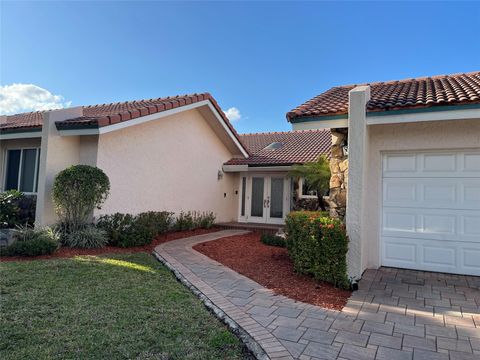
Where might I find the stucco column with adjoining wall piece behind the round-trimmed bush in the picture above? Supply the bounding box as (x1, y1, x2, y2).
(35, 107, 83, 226)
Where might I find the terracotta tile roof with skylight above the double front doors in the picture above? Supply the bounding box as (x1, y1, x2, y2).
(225, 130, 332, 166)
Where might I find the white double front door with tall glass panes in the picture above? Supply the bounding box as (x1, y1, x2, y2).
(240, 175, 290, 224)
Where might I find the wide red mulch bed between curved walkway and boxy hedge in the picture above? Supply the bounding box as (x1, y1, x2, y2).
(193, 233, 351, 310)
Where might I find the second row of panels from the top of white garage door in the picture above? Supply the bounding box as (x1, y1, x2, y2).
(383, 178, 480, 210)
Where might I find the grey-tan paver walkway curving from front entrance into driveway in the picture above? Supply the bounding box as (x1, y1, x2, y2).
(155, 230, 480, 360)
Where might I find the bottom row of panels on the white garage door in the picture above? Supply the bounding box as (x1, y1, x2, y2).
(382, 237, 480, 275)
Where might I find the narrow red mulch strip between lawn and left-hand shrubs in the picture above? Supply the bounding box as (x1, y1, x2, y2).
(0, 228, 220, 262)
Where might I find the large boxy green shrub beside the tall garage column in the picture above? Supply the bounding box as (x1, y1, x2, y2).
(286, 211, 350, 289)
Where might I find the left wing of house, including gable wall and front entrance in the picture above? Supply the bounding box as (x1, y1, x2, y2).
(0, 94, 331, 225)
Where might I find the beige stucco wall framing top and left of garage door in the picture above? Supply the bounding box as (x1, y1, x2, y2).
(362, 119, 480, 270)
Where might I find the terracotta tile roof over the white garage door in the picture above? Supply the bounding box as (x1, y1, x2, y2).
(287, 71, 480, 121)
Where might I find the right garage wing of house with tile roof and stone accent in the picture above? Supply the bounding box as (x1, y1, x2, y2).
(287, 72, 480, 279)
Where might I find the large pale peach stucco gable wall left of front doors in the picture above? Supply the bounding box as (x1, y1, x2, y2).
(95, 110, 238, 221)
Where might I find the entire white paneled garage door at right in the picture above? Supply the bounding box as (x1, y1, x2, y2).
(381, 150, 480, 275)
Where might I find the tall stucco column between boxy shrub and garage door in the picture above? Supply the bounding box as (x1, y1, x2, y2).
(345, 86, 370, 280)
